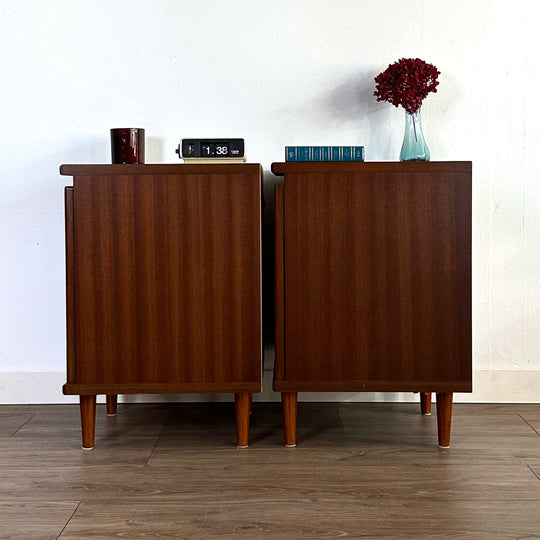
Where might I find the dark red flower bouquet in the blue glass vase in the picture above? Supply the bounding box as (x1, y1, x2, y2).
(373, 58, 441, 114)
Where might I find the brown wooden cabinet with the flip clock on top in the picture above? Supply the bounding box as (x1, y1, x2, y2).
(60, 164, 262, 448)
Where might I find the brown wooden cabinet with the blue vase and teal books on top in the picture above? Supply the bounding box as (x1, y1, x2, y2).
(272, 162, 472, 447)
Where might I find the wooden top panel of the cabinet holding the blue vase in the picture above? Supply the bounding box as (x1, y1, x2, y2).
(272, 161, 472, 176)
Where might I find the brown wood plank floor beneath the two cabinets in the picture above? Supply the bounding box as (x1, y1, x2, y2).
(0, 403, 540, 540)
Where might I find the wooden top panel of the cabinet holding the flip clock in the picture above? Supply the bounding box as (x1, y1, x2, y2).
(60, 163, 262, 176)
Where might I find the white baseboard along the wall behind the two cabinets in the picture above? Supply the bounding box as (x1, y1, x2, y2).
(0, 370, 540, 405)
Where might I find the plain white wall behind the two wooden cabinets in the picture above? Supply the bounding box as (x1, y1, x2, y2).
(0, 0, 540, 403)
